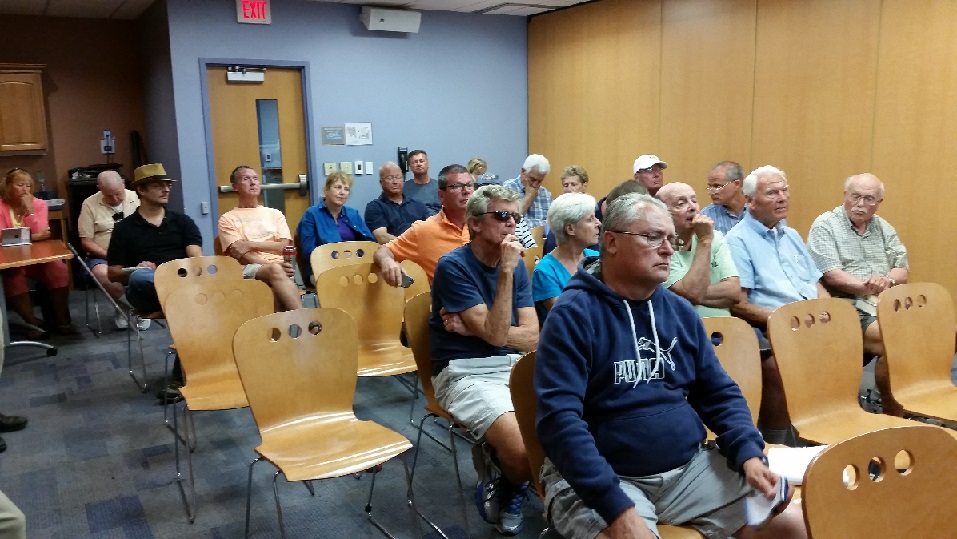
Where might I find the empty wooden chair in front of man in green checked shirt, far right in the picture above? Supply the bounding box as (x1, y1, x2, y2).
(877, 283, 957, 423)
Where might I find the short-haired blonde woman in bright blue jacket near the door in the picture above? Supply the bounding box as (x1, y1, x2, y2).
(296, 171, 375, 283)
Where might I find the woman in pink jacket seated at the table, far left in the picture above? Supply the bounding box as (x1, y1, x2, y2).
(0, 168, 76, 339)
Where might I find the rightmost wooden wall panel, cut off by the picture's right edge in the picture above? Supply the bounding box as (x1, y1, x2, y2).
(872, 0, 957, 294)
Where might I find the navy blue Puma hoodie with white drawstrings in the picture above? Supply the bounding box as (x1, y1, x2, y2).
(535, 257, 764, 523)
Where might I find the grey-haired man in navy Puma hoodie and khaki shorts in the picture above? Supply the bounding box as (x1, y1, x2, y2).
(534, 194, 806, 539)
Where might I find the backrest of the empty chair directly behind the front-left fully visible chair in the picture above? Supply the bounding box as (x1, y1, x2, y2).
(165, 278, 273, 392)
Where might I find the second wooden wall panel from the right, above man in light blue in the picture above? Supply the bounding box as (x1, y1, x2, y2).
(751, 0, 880, 237)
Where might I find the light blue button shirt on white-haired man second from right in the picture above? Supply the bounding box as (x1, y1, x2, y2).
(725, 213, 822, 309)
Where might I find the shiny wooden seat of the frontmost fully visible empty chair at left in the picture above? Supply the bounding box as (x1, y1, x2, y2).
(256, 417, 412, 481)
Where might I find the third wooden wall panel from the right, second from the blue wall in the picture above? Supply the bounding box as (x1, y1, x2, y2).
(656, 0, 757, 194)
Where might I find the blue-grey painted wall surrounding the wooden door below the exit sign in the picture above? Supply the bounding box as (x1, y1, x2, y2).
(160, 0, 528, 250)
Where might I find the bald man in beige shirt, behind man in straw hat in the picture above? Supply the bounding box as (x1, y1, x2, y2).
(76, 170, 142, 329)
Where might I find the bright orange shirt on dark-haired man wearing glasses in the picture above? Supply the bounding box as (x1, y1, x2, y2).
(385, 209, 472, 284)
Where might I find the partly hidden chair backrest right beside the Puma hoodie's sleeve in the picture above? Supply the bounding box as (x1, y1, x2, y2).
(704, 316, 762, 423)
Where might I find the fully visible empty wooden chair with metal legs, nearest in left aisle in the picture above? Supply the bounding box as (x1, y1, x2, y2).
(233, 308, 412, 537)
